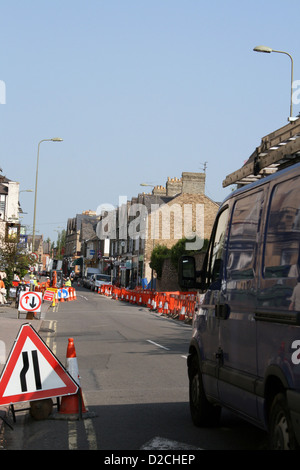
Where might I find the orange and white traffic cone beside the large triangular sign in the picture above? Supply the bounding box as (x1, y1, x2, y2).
(59, 338, 87, 416)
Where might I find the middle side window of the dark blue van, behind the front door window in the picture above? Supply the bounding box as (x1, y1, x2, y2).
(227, 191, 263, 279)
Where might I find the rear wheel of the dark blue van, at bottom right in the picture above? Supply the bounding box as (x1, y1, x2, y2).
(269, 393, 298, 450)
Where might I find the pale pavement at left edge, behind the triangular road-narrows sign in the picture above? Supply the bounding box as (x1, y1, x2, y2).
(0, 301, 51, 434)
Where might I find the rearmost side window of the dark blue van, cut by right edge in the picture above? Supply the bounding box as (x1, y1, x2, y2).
(263, 177, 300, 278)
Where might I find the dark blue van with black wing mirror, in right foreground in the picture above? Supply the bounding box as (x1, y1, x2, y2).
(179, 163, 300, 449)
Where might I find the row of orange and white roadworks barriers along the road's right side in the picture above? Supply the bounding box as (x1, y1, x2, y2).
(98, 284, 198, 323)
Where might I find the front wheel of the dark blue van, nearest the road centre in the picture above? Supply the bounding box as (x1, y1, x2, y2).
(189, 357, 221, 426)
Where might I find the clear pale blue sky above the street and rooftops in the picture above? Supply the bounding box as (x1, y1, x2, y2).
(0, 0, 300, 240)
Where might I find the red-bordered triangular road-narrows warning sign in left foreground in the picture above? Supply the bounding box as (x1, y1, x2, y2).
(0, 323, 79, 405)
